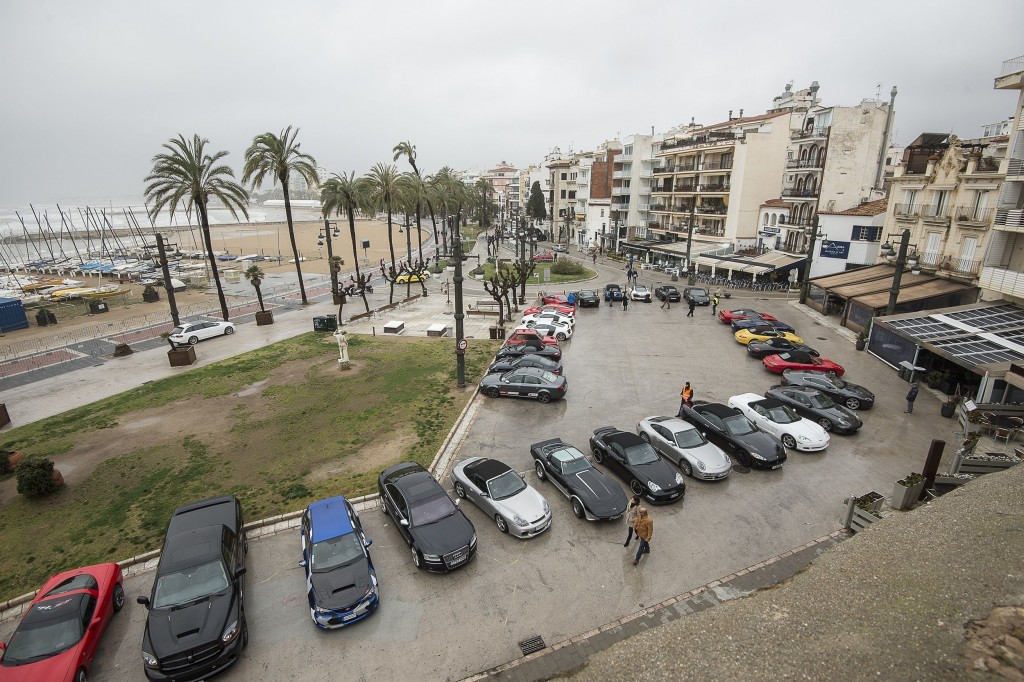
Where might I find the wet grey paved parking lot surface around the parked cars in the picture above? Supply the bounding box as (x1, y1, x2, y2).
(0, 280, 953, 680)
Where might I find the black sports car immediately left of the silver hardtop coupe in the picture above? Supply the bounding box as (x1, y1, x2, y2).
(590, 426, 686, 504)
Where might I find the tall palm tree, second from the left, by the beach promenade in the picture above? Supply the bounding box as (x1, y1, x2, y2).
(242, 126, 319, 305)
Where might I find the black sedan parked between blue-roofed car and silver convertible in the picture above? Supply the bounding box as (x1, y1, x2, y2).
(377, 462, 476, 573)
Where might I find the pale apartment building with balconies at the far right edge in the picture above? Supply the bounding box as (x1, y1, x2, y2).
(975, 55, 1024, 303)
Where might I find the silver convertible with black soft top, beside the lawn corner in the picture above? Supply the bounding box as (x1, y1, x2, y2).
(452, 457, 551, 538)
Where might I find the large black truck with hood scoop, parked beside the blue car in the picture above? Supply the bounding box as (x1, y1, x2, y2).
(138, 496, 249, 680)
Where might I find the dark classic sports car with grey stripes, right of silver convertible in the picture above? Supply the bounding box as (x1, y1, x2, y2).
(529, 438, 627, 521)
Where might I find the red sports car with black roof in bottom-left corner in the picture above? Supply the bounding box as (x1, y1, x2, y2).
(0, 563, 125, 682)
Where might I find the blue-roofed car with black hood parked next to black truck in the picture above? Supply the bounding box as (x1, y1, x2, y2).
(299, 496, 380, 630)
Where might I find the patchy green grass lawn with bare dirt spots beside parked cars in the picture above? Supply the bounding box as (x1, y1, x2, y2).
(0, 334, 498, 600)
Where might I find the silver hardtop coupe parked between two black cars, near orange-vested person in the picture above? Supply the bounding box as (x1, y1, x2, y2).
(637, 417, 732, 480)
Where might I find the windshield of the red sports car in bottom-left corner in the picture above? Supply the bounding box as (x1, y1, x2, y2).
(3, 594, 89, 667)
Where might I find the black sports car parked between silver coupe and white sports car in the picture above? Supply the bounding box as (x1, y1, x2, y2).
(683, 400, 786, 469)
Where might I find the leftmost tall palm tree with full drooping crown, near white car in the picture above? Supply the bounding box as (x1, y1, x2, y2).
(145, 135, 249, 322)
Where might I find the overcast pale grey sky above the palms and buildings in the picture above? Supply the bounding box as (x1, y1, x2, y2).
(0, 0, 1024, 205)
